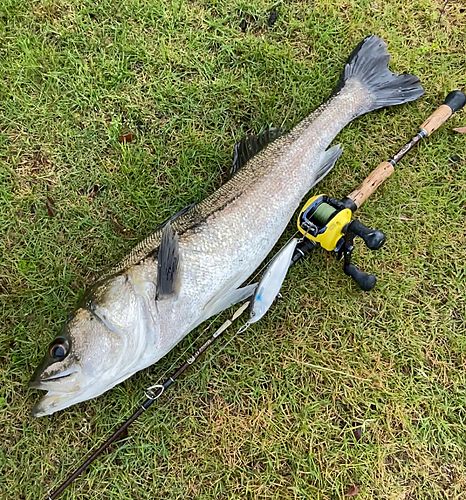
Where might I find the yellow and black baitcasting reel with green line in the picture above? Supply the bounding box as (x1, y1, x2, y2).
(293, 195, 385, 291)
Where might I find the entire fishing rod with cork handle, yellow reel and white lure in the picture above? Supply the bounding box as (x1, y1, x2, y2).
(42, 91, 466, 500)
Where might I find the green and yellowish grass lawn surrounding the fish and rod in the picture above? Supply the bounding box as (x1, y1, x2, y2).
(0, 0, 466, 500)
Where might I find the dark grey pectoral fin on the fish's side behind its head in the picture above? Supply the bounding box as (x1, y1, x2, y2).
(157, 221, 180, 300)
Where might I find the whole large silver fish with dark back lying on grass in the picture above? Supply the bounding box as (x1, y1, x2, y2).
(29, 35, 424, 417)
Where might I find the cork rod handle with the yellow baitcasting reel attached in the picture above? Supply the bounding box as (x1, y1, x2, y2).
(293, 90, 466, 291)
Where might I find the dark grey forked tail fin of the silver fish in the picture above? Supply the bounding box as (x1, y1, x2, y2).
(334, 35, 424, 114)
